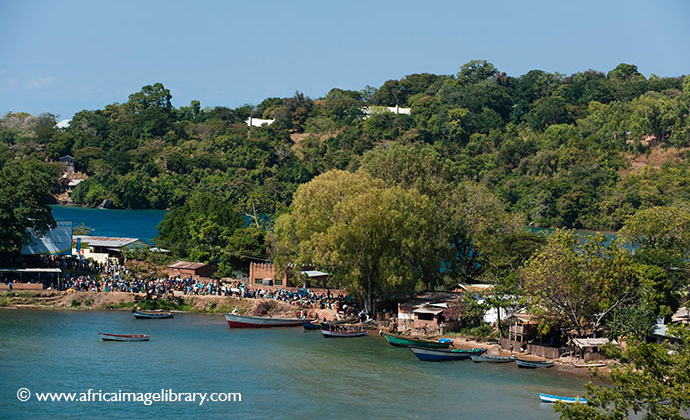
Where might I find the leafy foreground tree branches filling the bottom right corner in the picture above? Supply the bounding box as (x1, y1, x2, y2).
(555, 326, 690, 420)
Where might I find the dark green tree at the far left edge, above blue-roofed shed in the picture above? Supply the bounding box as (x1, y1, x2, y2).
(0, 159, 57, 256)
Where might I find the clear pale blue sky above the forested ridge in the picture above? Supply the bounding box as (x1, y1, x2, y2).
(0, 0, 690, 120)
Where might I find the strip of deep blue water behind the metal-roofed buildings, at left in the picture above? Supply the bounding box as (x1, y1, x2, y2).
(50, 206, 166, 242)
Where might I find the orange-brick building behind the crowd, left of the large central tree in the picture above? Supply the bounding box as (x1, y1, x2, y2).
(249, 262, 328, 289)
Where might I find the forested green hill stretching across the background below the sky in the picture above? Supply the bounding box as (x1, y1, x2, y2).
(0, 61, 690, 230)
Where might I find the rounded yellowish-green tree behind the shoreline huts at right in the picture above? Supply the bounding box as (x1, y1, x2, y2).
(520, 229, 641, 337)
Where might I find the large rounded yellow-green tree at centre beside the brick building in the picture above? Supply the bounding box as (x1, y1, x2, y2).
(274, 171, 441, 311)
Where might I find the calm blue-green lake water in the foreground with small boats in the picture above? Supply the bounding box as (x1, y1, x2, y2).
(0, 309, 584, 420)
